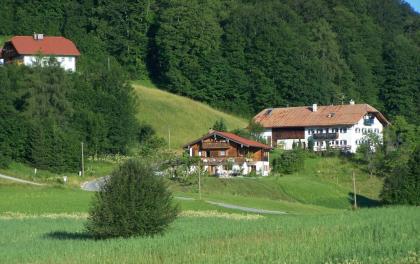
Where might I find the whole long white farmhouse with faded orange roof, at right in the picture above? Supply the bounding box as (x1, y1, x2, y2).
(254, 101, 389, 153)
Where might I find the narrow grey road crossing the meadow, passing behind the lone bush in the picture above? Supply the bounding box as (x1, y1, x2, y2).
(80, 177, 287, 215)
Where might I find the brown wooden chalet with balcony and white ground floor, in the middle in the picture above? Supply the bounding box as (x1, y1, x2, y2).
(184, 130, 271, 176)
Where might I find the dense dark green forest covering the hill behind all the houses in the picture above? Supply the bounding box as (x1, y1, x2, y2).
(0, 0, 420, 121)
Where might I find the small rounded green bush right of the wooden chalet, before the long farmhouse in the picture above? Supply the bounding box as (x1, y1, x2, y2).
(273, 149, 305, 174)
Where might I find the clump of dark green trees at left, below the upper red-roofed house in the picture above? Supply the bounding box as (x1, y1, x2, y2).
(0, 65, 141, 171)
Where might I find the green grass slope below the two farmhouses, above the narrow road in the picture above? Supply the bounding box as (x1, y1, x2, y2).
(173, 156, 382, 209)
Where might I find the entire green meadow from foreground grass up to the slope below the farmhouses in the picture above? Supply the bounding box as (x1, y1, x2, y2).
(0, 157, 420, 263)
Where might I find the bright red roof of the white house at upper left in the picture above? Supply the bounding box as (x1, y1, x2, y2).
(10, 36, 80, 56)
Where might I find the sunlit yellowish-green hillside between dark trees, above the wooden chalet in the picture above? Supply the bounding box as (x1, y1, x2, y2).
(133, 82, 247, 148)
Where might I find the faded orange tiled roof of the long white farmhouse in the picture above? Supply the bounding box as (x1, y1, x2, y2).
(254, 104, 389, 128)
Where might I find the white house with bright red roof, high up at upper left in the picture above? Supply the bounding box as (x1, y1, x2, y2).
(1, 33, 80, 72)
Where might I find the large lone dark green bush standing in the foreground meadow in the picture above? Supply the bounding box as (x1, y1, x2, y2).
(86, 160, 178, 238)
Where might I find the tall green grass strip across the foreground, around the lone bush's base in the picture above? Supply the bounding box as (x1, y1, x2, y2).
(0, 207, 420, 263)
